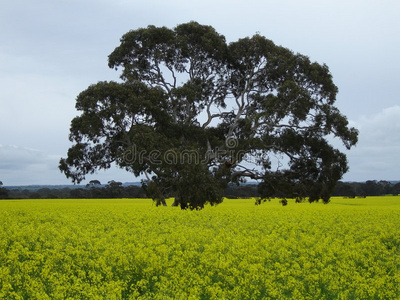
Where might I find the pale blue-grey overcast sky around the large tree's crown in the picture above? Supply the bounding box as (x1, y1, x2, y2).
(0, 0, 400, 185)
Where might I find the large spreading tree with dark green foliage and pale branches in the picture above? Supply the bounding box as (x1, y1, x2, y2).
(59, 22, 358, 208)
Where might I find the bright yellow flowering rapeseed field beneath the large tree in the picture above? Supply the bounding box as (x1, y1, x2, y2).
(0, 197, 400, 300)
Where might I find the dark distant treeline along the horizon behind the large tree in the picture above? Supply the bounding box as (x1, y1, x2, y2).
(0, 180, 400, 199)
